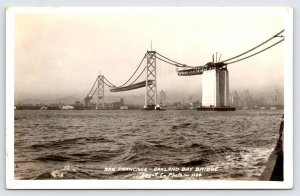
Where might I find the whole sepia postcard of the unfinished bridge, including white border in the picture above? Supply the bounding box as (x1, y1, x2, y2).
(6, 7, 293, 189)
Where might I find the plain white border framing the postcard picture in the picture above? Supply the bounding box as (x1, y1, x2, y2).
(6, 7, 293, 189)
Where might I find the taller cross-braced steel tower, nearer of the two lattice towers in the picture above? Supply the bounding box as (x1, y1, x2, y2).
(144, 51, 157, 109)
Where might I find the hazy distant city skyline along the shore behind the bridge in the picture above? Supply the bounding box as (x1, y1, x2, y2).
(15, 89, 284, 108)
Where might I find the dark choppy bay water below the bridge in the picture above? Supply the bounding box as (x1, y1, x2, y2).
(15, 110, 283, 180)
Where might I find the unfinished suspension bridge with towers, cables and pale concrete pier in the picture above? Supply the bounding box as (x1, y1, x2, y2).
(84, 30, 284, 110)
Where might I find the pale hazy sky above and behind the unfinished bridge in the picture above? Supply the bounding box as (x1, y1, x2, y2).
(15, 8, 285, 101)
